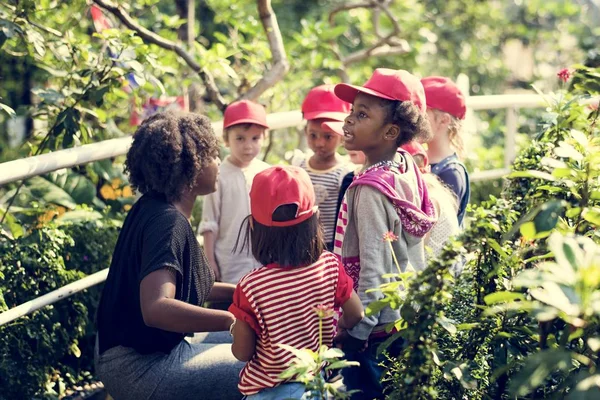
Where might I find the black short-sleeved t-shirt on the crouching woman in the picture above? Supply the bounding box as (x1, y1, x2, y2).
(98, 193, 214, 354)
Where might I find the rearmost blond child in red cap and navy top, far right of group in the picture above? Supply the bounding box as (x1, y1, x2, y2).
(421, 76, 471, 225)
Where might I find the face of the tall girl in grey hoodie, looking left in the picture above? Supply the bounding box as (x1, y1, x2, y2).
(344, 93, 395, 153)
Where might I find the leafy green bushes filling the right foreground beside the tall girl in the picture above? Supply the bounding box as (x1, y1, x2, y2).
(370, 70, 600, 399)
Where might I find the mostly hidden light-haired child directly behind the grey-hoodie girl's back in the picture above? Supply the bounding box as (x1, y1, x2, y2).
(401, 141, 461, 260)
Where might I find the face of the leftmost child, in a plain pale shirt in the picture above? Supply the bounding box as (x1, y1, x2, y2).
(225, 125, 265, 167)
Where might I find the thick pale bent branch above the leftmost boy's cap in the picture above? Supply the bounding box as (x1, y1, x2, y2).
(240, 0, 290, 100)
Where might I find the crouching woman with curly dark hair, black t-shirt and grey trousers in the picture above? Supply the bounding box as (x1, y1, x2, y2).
(95, 113, 243, 400)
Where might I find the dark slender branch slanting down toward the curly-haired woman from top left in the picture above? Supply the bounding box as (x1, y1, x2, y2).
(93, 0, 227, 111)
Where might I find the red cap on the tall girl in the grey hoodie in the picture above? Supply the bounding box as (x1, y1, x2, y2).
(335, 68, 426, 112)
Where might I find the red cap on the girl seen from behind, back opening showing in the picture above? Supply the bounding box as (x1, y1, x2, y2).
(250, 165, 318, 227)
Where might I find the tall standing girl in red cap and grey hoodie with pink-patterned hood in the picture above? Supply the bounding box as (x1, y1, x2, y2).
(335, 68, 436, 399)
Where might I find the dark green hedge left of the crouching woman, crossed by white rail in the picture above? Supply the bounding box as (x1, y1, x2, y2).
(0, 220, 118, 400)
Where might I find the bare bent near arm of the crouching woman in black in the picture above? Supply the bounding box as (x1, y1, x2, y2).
(140, 268, 234, 333)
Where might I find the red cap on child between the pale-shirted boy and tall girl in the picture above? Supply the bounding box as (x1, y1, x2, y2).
(302, 85, 352, 122)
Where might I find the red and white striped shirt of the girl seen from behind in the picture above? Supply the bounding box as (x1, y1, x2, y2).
(229, 251, 352, 396)
